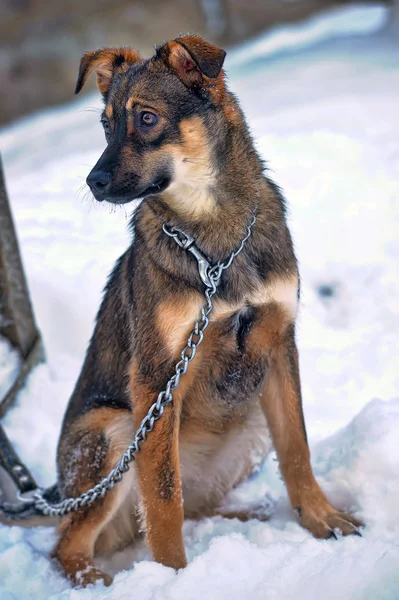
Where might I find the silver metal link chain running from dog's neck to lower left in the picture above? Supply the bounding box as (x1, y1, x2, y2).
(31, 213, 256, 517)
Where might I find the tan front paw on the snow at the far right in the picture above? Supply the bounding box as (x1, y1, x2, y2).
(295, 498, 364, 539)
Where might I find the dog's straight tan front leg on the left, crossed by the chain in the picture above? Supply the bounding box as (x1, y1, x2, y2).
(130, 368, 187, 569)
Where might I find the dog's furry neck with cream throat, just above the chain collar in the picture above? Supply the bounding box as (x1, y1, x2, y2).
(147, 110, 267, 259)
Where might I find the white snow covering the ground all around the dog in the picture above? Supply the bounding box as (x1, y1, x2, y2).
(0, 7, 399, 600)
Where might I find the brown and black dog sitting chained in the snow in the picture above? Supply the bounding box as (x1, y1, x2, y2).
(54, 36, 361, 585)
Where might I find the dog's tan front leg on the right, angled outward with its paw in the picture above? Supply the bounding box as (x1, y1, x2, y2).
(255, 315, 362, 538)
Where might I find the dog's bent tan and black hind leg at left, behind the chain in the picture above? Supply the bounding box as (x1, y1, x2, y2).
(52, 408, 135, 586)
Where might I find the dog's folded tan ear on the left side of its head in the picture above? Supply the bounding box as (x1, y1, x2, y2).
(75, 48, 141, 96)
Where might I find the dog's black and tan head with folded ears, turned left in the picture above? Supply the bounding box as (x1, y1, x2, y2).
(76, 36, 230, 213)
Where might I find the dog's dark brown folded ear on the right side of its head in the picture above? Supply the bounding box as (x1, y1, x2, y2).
(158, 35, 226, 86)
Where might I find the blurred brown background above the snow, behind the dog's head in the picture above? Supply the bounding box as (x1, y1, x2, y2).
(0, 0, 398, 126)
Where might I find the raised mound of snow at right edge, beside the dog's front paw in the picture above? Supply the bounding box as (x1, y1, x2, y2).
(313, 398, 399, 542)
